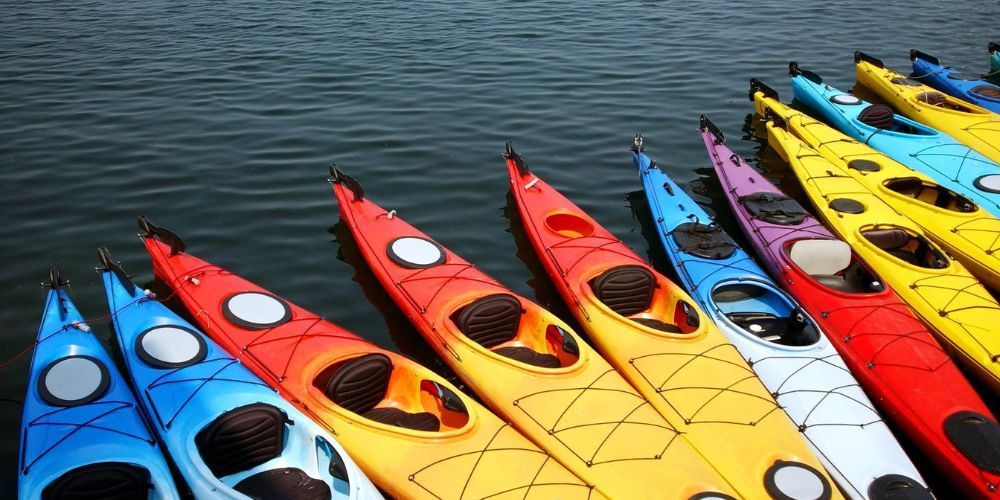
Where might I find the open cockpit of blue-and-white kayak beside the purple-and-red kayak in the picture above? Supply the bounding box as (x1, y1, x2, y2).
(712, 281, 820, 346)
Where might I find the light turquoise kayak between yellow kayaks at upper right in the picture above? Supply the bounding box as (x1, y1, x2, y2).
(789, 62, 1000, 216)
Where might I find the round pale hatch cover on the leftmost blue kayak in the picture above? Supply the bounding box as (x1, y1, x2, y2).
(38, 356, 111, 406)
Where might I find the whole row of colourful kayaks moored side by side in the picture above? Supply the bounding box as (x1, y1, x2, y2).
(19, 44, 1000, 500)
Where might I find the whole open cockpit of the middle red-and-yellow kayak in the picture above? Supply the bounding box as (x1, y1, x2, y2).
(451, 293, 580, 368)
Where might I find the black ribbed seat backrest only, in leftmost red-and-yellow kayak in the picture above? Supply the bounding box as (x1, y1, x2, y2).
(323, 352, 392, 414)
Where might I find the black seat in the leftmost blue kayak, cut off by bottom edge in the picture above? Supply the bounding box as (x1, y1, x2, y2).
(42, 462, 153, 500)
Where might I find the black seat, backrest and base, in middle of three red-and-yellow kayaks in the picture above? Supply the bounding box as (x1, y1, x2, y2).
(452, 293, 561, 368)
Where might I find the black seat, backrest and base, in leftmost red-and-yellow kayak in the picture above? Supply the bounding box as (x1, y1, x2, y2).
(323, 352, 441, 431)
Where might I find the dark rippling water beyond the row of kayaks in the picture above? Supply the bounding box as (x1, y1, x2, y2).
(0, 0, 1000, 497)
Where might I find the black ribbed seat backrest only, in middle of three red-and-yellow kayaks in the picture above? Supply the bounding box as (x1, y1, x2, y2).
(452, 293, 522, 349)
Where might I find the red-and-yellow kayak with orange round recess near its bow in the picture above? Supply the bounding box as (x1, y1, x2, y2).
(505, 143, 840, 498)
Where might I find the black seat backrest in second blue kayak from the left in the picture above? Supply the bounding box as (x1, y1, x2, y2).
(195, 403, 288, 477)
